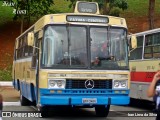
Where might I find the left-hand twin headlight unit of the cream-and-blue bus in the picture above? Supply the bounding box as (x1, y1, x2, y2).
(48, 79, 66, 89)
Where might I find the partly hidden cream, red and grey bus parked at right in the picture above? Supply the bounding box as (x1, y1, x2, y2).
(129, 28, 160, 101)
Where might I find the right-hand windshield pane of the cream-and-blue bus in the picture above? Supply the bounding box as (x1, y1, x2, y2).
(90, 27, 128, 69)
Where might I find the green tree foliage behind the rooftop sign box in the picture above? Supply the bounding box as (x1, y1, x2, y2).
(67, 0, 128, 16)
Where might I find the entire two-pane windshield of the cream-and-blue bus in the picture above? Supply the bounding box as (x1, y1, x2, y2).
(42, 25, 128, 69)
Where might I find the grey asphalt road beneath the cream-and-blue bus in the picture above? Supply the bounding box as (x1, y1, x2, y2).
(3, 106, 155, 120)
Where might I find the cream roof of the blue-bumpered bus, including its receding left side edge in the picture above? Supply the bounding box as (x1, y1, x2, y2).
(17, 13, 127, 39)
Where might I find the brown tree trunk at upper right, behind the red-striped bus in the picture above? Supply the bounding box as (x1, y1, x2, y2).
(148, 0, 155, 29)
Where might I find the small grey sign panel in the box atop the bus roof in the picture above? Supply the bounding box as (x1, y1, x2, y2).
(78, 2, 97, 14)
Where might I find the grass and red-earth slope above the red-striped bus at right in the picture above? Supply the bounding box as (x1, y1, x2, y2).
(121, 0, 160, 33)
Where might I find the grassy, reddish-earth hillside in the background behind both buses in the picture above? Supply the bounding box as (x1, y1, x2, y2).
(0, 0, 160, 80)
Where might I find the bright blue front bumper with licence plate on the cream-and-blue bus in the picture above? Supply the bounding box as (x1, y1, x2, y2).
(40, 95, 130, 106)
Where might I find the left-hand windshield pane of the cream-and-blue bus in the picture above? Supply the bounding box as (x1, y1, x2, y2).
(42, 25, 87, 68)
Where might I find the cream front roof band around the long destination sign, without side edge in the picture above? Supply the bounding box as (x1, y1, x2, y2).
(35, 13, 127, 31)
